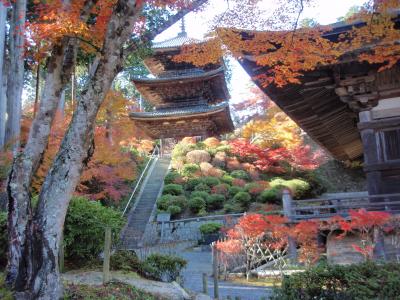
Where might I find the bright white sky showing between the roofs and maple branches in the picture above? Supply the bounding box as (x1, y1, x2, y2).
(155, 0, 365, 109)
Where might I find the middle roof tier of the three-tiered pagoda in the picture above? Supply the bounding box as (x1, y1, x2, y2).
(133, 66, 229, 106)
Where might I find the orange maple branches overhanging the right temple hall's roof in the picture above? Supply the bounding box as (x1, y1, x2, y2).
(175, 0, 400, 86)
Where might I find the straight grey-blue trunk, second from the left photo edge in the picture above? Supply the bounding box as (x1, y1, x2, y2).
(5, 0, 26, 153)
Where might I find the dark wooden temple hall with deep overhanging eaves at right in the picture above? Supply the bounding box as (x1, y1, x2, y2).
(234, 23, 400, 195)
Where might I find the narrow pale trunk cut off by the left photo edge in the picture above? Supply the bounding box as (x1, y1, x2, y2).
(0, 1, 7, 151)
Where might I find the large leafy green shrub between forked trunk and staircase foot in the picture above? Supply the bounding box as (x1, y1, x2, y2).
(64, 197, 125, 262)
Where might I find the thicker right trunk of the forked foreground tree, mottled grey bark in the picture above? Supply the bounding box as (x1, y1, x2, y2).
(9, 0, 141, 300)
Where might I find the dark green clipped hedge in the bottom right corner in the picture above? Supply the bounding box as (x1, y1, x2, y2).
(271, 262, 400, 300)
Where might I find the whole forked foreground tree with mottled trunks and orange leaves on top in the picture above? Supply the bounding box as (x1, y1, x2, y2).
(7, 0, 205, 299)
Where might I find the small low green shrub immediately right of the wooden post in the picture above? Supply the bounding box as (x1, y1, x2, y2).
(110, 250, 143, 274)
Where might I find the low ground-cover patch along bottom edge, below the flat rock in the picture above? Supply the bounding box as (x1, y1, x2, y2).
(64, 282, 156, 300)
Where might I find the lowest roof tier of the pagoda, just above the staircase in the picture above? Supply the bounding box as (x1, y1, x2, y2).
(129, 102, 234, 138)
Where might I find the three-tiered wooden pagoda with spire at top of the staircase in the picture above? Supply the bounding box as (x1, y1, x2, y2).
(130, 23, 234, 139)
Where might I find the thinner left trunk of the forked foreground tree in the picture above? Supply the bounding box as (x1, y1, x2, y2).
(6, 0, 97, 291)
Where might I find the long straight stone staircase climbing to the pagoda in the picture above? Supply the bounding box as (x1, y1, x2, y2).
(120, 157, 171, 249)
